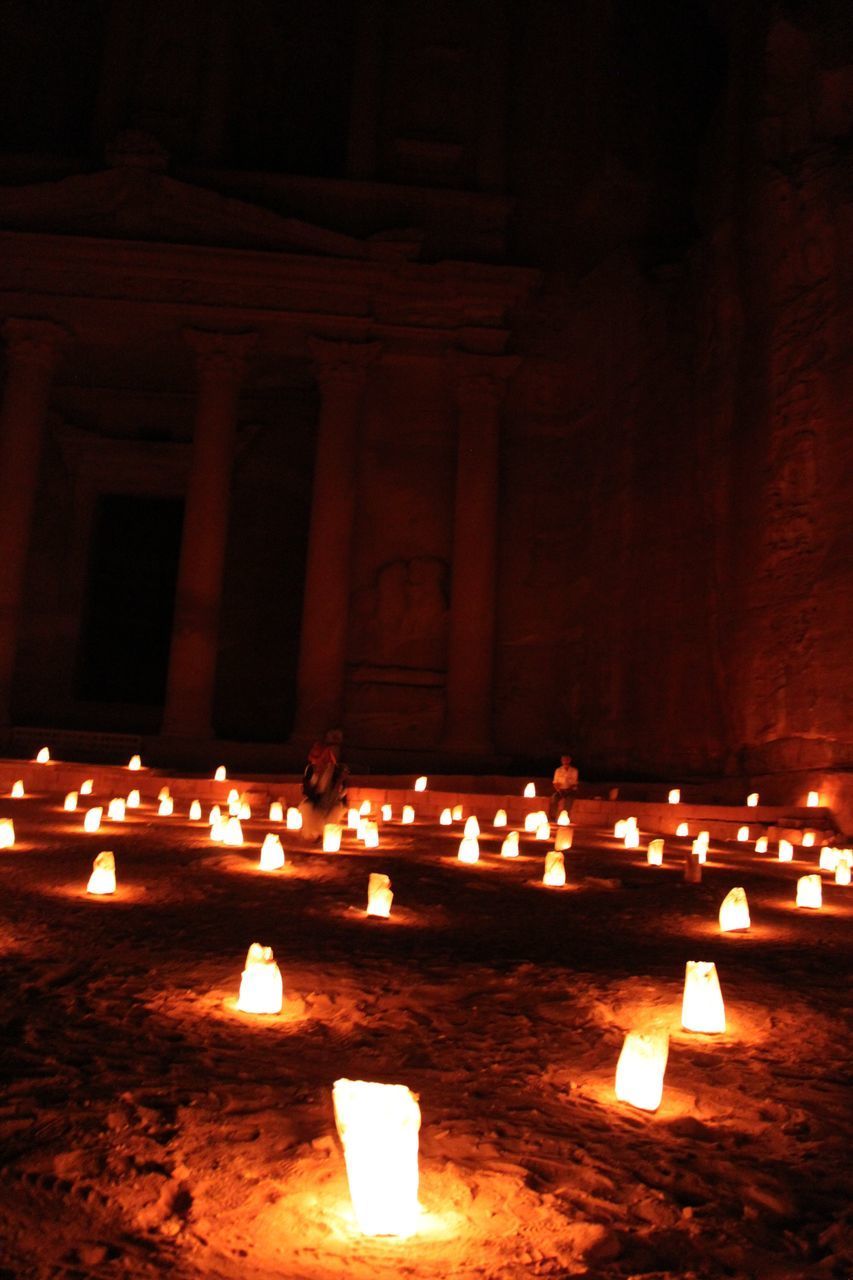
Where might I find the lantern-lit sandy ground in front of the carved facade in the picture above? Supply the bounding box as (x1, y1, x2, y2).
(0, 796, 853, 1280)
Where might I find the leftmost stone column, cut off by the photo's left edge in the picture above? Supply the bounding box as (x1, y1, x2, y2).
(0, 319, 67, 724)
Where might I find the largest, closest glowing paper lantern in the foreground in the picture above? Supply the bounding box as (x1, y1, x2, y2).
(332, 1079, 420, 1235)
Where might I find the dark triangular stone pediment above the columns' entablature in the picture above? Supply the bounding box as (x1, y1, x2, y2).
(0, 165, 418, 260)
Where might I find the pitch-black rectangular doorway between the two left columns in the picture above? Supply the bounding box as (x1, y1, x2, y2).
(77, 494, 183, 707)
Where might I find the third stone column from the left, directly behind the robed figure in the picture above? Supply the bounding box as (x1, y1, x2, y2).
(293, 338, 382, 742)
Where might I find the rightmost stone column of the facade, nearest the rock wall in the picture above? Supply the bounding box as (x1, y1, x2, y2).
(443, 353, 519, 753)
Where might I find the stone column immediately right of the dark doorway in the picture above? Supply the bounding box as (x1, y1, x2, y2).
(163, 329, 256, 739)
